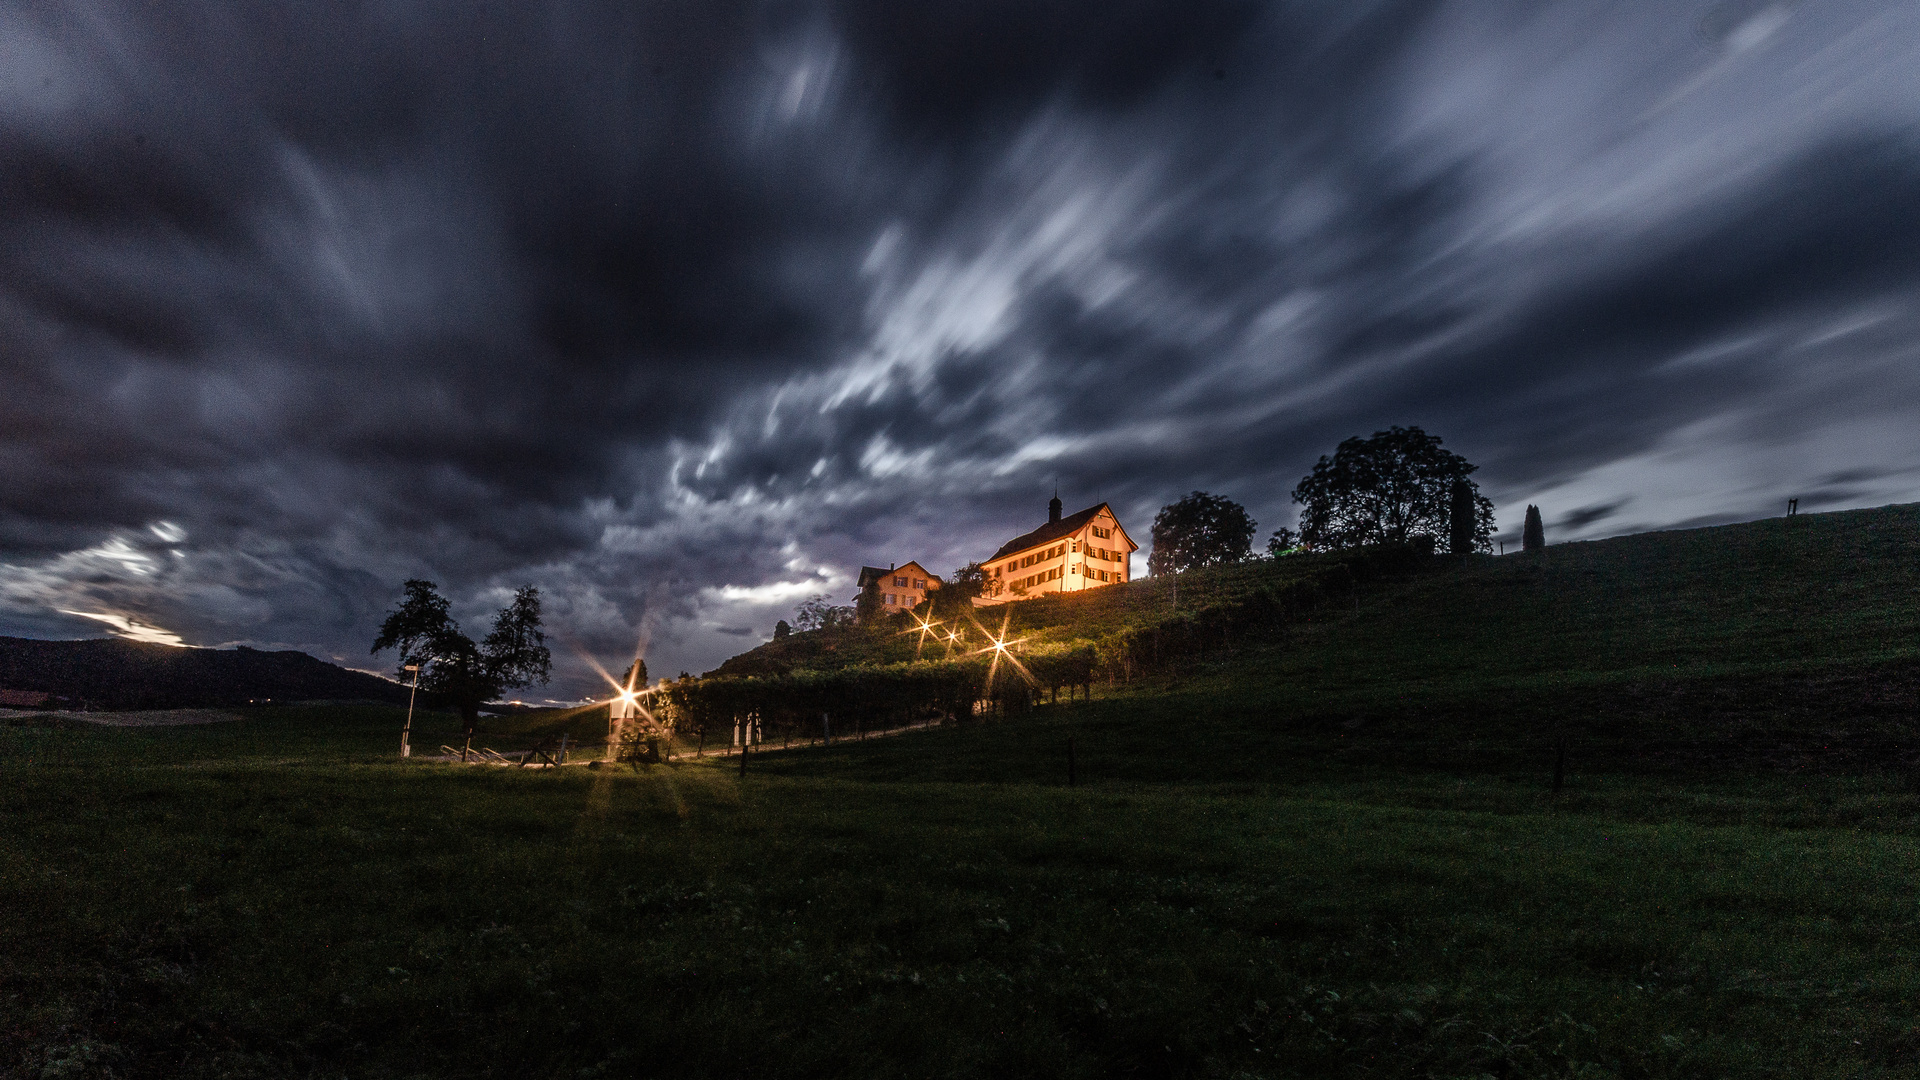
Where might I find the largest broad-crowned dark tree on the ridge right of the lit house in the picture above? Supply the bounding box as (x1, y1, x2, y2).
(1294, 427, 1494, 552)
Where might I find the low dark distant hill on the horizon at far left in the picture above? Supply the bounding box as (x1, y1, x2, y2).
(0, 638, 424, 709)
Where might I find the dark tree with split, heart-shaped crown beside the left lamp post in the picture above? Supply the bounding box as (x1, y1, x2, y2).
(372, 578, 553, 736)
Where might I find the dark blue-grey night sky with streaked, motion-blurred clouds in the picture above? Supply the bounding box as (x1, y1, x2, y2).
(0, 0, 1920, 698)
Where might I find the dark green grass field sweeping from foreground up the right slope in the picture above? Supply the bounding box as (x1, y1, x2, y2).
(11, 507, 1920, 1078)
